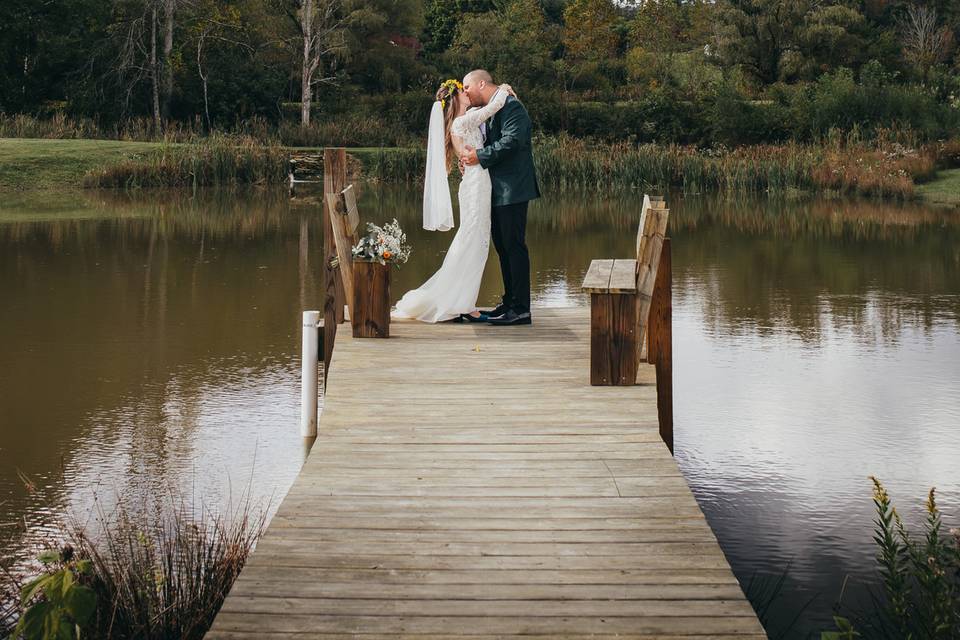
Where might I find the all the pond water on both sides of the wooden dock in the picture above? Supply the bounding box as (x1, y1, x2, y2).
(0, 185, 960, 638)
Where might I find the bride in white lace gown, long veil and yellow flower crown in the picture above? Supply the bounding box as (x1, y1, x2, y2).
(393, 80, 515, 322)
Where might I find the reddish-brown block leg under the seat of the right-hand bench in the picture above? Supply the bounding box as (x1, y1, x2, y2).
(590, 293, 640, 386)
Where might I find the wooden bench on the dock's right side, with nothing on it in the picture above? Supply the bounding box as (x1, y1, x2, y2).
(583, 196, 670, 385)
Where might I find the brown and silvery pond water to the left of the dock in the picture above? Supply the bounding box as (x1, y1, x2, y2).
(0, 193, 319, 568)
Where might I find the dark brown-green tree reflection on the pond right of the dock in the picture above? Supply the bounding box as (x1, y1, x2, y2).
(672, 203, 960, 341)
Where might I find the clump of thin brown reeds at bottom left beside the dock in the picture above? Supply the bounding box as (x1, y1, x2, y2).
(0, 498, 265, 640)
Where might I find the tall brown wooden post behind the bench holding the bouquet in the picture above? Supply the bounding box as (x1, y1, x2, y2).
(320, 148, 349, 386)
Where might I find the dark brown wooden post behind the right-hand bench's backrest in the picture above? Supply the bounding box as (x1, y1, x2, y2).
(647, 238, 673, 453)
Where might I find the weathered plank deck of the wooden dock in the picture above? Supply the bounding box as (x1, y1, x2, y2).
(207, 308, 766, 640)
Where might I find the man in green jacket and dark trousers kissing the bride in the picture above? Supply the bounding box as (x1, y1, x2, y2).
(461, 69, 540, 325)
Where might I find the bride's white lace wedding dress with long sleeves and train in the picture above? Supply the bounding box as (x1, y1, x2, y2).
(392, 91, 507, 322)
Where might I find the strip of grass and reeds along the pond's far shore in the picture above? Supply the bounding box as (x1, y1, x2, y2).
(0, 135, 960, 202)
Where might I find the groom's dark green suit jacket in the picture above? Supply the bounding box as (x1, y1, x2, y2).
(477, 96, 540, 207)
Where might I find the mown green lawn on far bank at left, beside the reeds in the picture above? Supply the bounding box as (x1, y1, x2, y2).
(0, 138, 160, 190)
